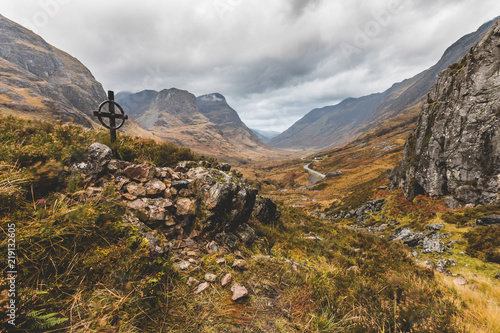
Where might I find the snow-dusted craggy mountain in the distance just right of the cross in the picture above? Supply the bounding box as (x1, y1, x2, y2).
(116, 88, 275, 163)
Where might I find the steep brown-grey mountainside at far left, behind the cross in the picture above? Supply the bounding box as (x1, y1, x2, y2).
(0, 15, 160, 141)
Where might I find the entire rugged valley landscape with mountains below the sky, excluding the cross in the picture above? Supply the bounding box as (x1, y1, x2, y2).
(0, 9, 500, 333)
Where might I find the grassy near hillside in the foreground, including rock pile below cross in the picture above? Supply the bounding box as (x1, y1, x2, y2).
(0, 118, 461, 332)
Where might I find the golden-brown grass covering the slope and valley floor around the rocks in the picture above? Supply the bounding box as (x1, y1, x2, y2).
(0, 119, 499, 332)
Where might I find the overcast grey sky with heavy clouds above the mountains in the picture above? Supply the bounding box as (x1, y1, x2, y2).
(1, 0, 500, 131)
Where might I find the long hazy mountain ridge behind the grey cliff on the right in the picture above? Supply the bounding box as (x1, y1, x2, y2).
(269, 16, 496, 150)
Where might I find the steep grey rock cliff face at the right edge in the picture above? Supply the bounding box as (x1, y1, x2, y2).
(392, 21, 500, 204)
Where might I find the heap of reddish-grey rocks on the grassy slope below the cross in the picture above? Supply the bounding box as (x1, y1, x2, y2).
(72, 143, 270, 252)
